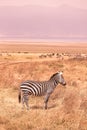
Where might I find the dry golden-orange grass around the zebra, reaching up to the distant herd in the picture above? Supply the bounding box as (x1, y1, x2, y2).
(0, 42, 87, 130)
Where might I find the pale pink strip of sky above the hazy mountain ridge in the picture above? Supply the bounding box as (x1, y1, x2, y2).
(0, 0, 87, 9)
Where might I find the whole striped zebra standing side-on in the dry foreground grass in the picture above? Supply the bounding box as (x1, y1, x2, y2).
(18, 72, 66, 109)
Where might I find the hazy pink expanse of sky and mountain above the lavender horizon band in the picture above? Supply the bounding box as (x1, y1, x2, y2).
(0, 0, 87, 39)
